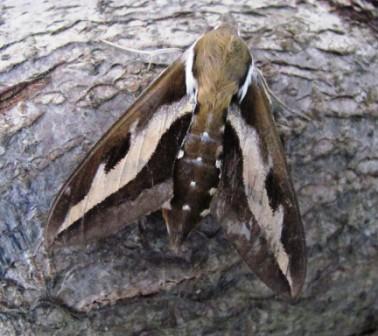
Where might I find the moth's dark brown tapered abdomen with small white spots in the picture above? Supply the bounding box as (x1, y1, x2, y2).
(163, 111, 223, 247)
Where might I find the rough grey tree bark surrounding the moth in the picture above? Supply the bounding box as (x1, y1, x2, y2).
(0, 0, 378, 336)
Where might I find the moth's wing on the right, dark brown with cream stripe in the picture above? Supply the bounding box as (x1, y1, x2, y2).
(212, 73, 306, 297)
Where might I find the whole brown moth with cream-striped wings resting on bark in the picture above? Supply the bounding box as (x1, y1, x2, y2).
(45, 23, 306, 297)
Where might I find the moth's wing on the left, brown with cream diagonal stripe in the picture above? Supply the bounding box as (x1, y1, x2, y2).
(46, 60, 192, 246)
